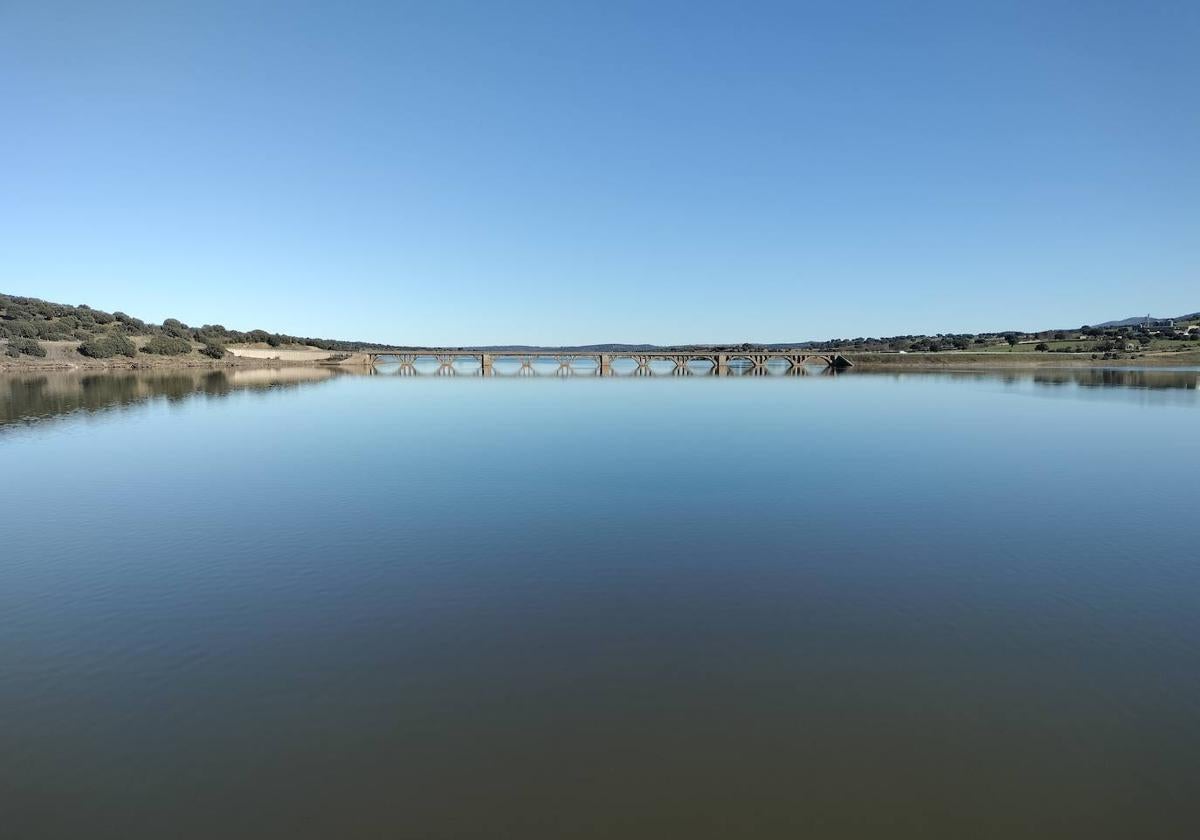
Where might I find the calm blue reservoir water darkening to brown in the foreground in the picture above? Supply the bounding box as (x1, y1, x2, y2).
(0, 371, 1200, 839)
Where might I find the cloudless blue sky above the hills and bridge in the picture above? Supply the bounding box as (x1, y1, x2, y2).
(0, 0, 1200, 344)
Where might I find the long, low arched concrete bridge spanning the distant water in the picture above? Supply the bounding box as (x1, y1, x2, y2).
(355, 348, 853, 377)
